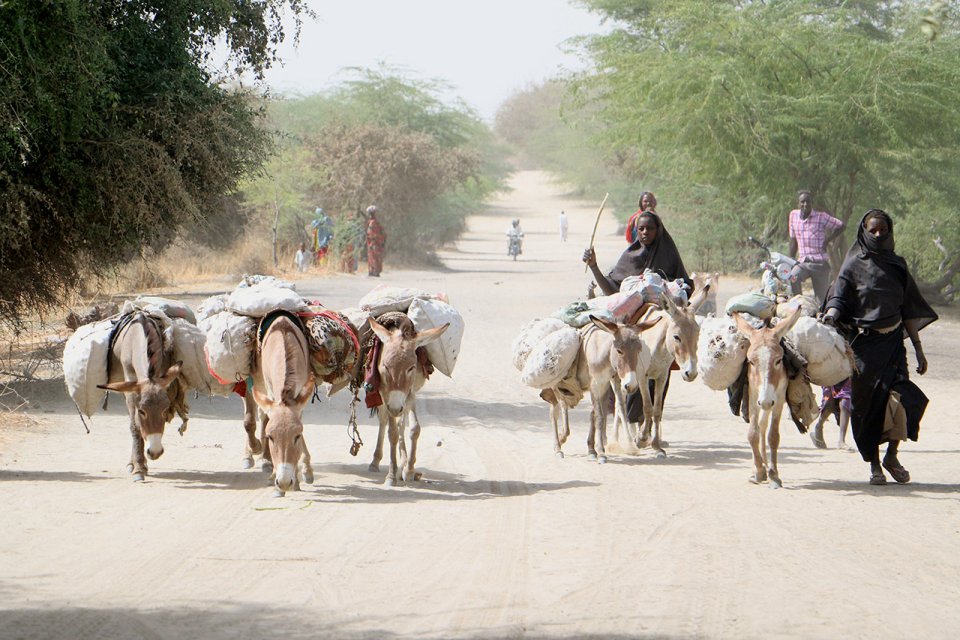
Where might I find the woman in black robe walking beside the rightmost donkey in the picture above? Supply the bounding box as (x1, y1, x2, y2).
(823, 209, 937, 484)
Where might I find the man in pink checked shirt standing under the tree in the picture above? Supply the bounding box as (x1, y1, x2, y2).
(789, 191, 846, 302)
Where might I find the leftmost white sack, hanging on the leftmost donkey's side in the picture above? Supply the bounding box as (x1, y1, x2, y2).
(63, 320, 113, 418)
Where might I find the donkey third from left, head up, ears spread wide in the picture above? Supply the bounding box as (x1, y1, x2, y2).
(369, 318, 450, 486)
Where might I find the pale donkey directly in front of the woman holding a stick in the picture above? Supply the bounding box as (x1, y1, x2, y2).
(622, 283, 710, 458)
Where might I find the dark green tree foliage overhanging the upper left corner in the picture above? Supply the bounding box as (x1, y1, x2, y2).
(0, 0, 304, 325)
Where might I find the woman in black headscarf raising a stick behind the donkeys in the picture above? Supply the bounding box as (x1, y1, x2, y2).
(583, 211, 693, 422)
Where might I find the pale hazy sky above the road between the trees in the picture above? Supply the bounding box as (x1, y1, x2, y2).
(267, 0, 602, 121)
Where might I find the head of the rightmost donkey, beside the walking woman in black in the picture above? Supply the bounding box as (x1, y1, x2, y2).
(733, 307, 801, 410)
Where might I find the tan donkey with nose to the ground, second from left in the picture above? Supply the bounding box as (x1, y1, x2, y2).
(251, 313, 315, 496)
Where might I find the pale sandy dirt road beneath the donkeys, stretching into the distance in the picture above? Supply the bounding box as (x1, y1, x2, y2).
(0, 173, 960, 639)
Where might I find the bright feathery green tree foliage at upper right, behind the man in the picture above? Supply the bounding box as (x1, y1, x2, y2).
(578, 0, 960, 288)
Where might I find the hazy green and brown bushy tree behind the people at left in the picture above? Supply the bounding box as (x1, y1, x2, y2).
(243, 68, 506, 268)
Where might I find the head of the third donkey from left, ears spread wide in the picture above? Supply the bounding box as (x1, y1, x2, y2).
(370, 318, 450, 417)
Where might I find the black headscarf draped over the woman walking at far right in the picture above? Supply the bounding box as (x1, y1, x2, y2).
(824, 209, 938, 331)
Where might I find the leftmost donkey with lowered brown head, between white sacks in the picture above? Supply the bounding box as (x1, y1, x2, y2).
(97, 311, 186, 482)
